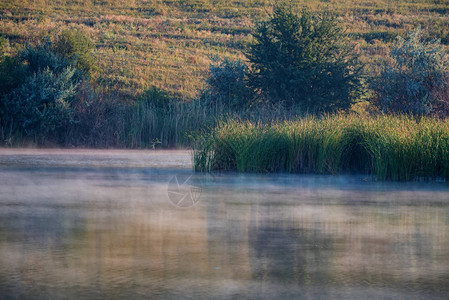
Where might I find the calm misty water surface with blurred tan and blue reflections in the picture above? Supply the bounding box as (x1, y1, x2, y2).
(0, 149, 449, 299)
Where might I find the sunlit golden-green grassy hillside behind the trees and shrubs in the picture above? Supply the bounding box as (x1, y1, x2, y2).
(0, 0, 449, 101)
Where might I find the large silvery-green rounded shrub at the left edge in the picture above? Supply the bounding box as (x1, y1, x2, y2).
(0, 38, 89, 142)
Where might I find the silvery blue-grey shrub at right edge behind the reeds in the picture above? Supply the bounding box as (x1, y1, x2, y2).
(373, 28, 449, 116)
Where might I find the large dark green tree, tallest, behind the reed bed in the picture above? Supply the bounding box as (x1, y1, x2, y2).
(247, 5, 362, 112)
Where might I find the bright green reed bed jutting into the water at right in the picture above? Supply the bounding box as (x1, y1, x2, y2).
(194, 115, 449, 181)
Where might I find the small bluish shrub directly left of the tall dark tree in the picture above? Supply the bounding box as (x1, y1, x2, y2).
(207, 57, 253, 109)
